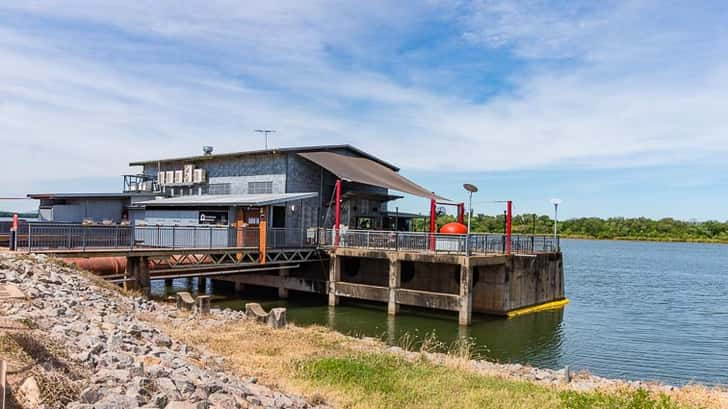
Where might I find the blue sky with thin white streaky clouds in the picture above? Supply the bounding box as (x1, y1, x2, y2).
(0, 0, 728, 220)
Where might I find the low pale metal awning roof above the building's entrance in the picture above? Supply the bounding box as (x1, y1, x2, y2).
(135, 192, 318, 207)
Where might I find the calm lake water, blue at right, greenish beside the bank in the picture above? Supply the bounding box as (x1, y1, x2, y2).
(154, 240, 728, 384)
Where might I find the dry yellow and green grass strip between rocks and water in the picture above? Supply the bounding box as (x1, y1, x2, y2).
(142, 317, 728, 409)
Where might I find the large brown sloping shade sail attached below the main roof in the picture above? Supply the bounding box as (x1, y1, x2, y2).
(299, 152, 448, 200)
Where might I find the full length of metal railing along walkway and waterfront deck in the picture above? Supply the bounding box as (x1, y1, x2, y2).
(11, 223, 559, 254)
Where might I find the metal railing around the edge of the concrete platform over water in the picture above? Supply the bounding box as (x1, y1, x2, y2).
(318, 229, 559, 254)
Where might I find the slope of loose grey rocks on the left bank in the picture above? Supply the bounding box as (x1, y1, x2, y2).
(0, 254, 328, 409)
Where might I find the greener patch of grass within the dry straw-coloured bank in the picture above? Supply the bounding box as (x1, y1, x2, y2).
(297, 353, 679, 409)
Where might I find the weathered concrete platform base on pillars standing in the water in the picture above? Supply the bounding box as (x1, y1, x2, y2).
(208, 242, 566, 326)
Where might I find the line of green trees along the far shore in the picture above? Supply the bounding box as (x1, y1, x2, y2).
(413, 214, 728, 242)
